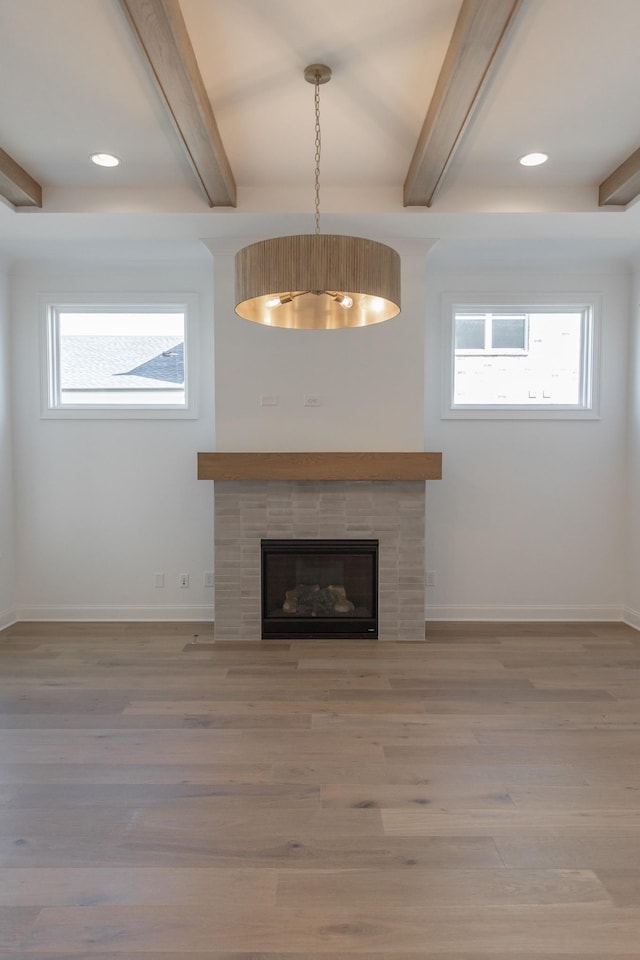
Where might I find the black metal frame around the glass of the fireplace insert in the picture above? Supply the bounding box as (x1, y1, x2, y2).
(260, 538, 379, 640)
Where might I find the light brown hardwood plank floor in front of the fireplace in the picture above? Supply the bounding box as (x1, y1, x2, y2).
(0, 624, 640, 960)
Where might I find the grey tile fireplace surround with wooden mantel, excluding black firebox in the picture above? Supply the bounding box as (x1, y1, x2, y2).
(198, 454, 440, 640)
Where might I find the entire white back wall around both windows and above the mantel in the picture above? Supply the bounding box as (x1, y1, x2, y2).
(0, 244, 640, 625)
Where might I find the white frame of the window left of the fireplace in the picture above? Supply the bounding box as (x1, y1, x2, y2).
(40, 292, 198, 420)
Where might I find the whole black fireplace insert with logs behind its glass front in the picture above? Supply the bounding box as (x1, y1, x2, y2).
(260, 539, 378, 639)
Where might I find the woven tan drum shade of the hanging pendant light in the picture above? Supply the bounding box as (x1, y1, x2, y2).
(235, 233, 400, 330)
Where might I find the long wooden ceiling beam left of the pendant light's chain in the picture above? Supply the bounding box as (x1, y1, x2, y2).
(120, 0, 236, 207)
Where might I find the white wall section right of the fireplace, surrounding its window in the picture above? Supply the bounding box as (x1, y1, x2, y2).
(425, 262, 629, 620)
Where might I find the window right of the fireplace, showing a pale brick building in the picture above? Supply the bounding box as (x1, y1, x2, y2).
(442, 296, 599, 419)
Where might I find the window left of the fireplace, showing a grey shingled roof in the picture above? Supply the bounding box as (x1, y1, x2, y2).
(42, 295, 196, 418)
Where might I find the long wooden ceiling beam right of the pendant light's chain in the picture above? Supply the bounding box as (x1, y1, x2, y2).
(404, 0, 522, 207)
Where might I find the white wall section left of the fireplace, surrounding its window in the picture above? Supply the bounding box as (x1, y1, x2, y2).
(12, 253, 214, 620)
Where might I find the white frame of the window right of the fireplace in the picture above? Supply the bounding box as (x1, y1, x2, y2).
(441, 292, 602, 420)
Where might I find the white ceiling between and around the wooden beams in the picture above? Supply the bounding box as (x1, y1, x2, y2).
(0, 0, 640, 257)
